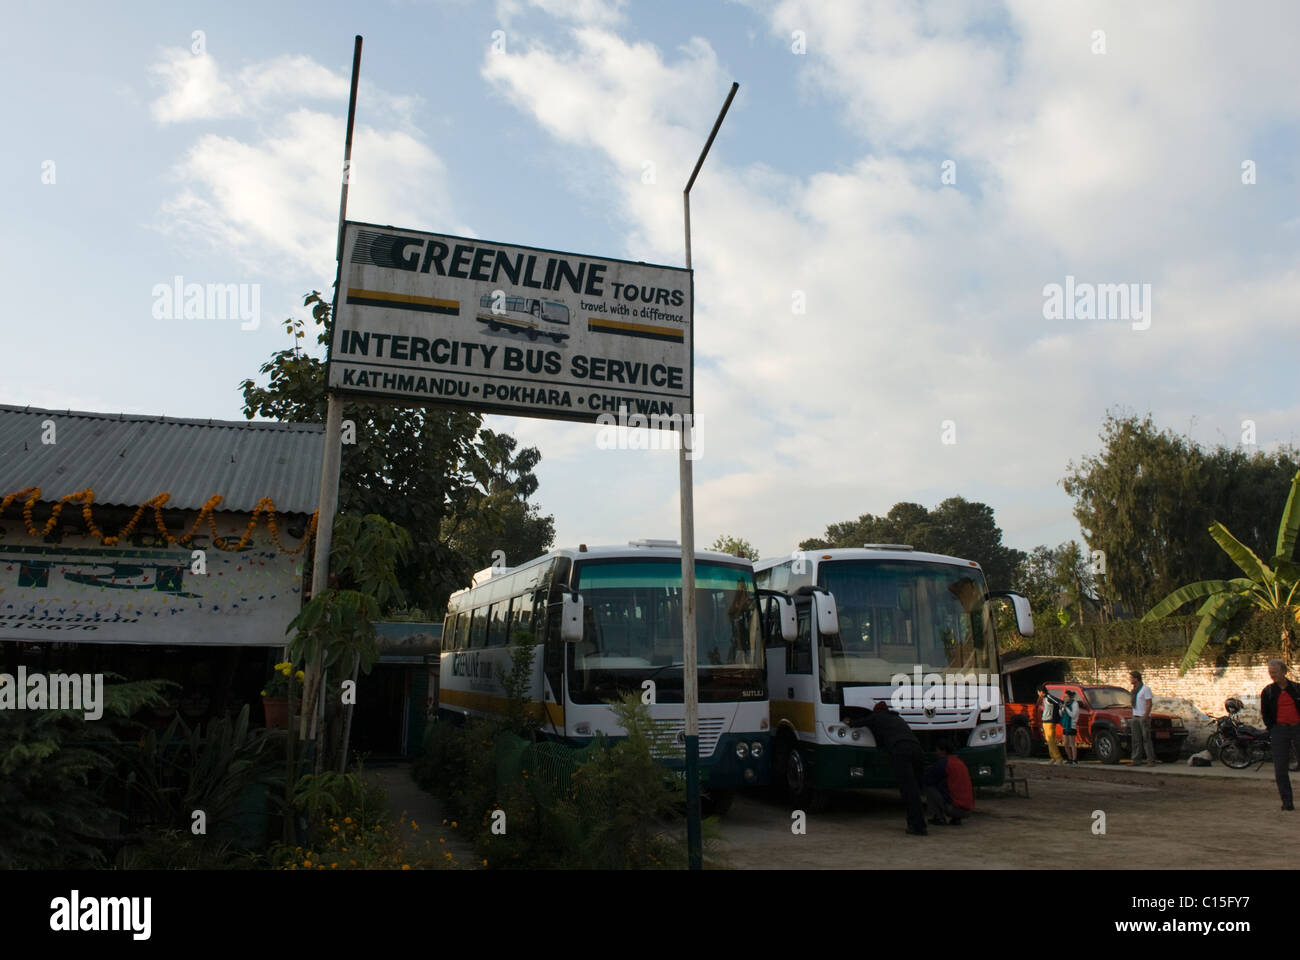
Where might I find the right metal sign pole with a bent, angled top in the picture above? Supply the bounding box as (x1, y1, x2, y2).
(679, 83, 740, 870)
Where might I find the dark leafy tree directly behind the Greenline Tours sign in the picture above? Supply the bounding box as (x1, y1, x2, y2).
(241, 291, 554, 611)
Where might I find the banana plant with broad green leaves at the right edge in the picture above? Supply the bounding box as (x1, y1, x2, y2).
(1143, 471, 1300, 675)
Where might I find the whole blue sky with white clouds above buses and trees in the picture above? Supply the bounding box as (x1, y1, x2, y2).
(0, 0, 1300, 564)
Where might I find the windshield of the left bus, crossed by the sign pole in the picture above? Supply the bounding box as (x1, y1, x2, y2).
(568, 559, 767, 702)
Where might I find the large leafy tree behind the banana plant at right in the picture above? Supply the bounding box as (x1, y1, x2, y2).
(1062, 414, 1300, 610)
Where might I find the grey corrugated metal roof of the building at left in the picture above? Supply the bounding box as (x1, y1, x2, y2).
(0, 403, 325, 514)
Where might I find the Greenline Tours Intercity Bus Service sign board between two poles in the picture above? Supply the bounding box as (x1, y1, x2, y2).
(328, 221, 694, 421)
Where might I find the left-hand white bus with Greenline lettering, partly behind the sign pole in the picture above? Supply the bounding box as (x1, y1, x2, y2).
(438, 540, 793, 812)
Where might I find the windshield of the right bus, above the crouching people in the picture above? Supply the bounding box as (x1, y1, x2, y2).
(818, 559, 996, 684)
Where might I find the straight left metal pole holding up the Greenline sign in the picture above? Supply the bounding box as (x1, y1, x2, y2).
(299, 34, 361, 749)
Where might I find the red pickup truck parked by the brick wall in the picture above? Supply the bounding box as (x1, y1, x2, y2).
(1005, 682, 1187, 764)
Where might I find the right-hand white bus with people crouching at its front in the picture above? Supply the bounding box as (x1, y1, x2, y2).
(754, 544, 1034, 807)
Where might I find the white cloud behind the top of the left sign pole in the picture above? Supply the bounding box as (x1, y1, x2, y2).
(153, 51, 464, 281)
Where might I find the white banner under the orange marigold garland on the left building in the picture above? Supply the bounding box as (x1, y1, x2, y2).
(0, 514, 303, 647)
